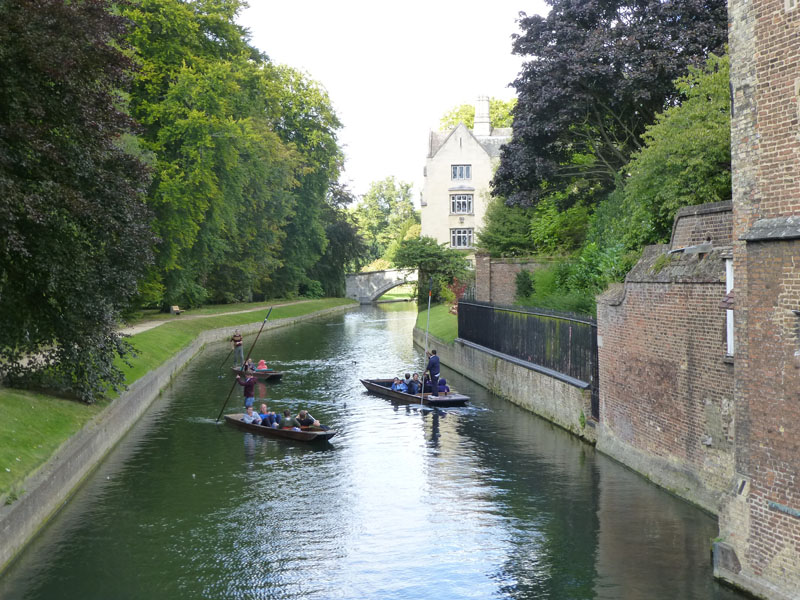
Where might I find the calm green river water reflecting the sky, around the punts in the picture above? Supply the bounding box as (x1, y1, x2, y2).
(0, 304, 740, 600)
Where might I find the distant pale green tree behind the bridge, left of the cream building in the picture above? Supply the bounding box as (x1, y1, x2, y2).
(355, 177, 420, 260)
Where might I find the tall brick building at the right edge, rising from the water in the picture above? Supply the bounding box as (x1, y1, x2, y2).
(714, 0, 800, 599)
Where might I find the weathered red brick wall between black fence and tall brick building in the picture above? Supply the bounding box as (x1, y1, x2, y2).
(597, 246, 734, 512)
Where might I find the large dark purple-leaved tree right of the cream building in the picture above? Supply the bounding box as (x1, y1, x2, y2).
(493, 0, 727, 205)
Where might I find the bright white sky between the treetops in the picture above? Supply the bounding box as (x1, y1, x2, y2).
(239, 0, 548, 202)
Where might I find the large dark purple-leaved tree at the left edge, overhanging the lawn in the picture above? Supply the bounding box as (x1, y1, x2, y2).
(0, 0, 153, 401)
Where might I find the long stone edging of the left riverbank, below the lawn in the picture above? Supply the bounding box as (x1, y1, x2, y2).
(0, 304, 359, 574)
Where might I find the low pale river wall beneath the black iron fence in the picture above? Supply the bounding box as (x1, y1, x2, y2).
(414, 328, 595, 442)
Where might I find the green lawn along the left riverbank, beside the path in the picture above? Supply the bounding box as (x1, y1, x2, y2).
(0, 298, 353, 502)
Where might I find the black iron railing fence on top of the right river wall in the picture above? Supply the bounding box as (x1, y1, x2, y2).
(458, 299, 599, 419)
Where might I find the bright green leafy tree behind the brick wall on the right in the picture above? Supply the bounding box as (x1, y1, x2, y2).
(624, 54, 731, 246)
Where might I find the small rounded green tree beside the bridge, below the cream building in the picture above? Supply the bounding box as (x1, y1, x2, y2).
(394, 236, 469, 304)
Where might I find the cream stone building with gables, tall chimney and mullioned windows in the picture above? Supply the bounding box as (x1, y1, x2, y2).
(420, 96, 511, 260)
